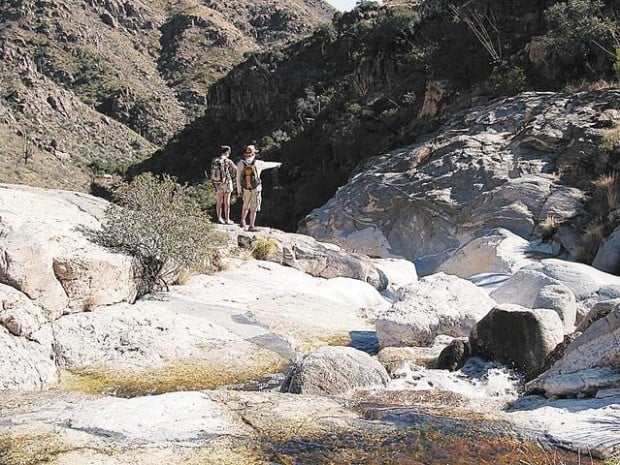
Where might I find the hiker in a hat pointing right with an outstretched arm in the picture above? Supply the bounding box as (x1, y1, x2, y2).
(237, 145, 282, 231)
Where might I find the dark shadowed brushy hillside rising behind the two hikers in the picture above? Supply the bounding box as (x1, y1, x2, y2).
(134, 1, 610, 230)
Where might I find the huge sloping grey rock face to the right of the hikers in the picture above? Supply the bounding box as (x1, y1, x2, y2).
(300, 90, 620, 275)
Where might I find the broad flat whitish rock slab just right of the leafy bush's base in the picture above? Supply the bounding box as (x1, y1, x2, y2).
(184, 260, 390, 352)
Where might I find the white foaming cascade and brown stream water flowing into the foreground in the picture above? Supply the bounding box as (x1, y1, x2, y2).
(239, 358, 603, 465)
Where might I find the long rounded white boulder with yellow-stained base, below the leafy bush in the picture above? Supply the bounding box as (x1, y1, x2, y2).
(54, 299, 287, 396)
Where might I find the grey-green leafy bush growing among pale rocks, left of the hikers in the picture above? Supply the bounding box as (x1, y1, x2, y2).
(101, 173, 222, 293)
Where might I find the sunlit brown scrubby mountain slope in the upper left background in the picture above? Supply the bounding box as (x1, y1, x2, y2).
(0, 0, 334, 189)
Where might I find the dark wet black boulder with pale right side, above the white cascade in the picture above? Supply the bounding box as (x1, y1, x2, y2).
(469, 304, 564, 379)
